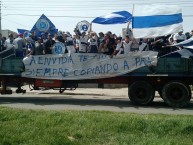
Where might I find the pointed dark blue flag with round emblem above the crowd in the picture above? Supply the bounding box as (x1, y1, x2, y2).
(31, 14, 58, 37)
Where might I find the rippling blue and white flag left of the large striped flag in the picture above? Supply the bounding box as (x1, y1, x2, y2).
(92, 11, 132, 24)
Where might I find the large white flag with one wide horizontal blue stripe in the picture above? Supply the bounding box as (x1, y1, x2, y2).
(132, 4, 183, 38)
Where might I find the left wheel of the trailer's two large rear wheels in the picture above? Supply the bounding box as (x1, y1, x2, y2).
(128, 81, 155, 105)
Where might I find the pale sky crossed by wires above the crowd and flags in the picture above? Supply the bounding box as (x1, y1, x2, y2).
(1, 0, 193, 35)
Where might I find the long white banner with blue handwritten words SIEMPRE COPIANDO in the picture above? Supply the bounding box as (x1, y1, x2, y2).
(22, 51, 157, 80)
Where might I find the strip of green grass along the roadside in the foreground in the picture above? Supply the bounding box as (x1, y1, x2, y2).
(0, 107, 193, 145)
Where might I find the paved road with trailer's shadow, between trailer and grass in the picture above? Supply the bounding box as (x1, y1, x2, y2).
(0, 88, 193, 115)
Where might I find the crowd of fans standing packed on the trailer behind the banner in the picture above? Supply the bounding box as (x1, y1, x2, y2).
(0, 29, 193, 58)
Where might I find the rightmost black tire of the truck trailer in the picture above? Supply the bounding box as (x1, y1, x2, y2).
(162, 81, 192, 108)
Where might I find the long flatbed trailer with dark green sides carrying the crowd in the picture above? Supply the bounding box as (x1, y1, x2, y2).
(0, 57, 193, 107)
